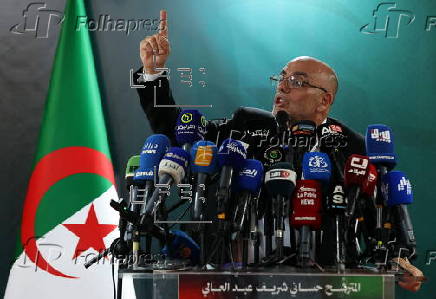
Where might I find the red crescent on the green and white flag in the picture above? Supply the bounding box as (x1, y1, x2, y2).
(21, 146, 115, 278)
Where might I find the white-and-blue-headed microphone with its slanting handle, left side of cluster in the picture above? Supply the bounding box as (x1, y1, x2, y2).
(141, 147, 189, 227)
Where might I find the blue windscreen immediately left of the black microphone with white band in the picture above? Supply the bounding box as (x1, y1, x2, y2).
(233, 159, 264, 195)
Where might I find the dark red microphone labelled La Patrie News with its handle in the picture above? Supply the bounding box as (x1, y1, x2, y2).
(291, 180, 322, 267)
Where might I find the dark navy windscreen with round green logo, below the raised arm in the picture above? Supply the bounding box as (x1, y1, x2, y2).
(175, 110, 207, 146)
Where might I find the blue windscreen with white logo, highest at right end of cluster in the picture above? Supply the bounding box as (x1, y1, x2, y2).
(365, 125, 397, 168)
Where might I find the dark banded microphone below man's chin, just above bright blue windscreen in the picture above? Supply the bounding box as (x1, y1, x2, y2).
(291, 120, 316, 178)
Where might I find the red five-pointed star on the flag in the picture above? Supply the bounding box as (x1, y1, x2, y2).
(64, 204, 117, 259)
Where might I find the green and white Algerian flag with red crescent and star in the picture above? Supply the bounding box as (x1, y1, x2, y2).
(5, 0, 119, 299)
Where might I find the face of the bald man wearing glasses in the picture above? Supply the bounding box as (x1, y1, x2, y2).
(272, 60, 325, 121)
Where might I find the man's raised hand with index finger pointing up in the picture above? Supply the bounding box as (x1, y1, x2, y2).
(139, 10, 170, 74)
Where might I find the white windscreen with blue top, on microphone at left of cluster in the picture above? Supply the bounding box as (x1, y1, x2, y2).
(159, 147, 189, 184)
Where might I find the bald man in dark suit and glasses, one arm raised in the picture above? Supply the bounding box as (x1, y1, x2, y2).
(134, 11, 419, 289)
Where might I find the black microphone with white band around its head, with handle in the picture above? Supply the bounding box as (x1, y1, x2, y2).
(265, 162, 297, 260)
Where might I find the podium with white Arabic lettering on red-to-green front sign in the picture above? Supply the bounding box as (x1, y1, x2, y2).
(118, 267, 395, 299)
